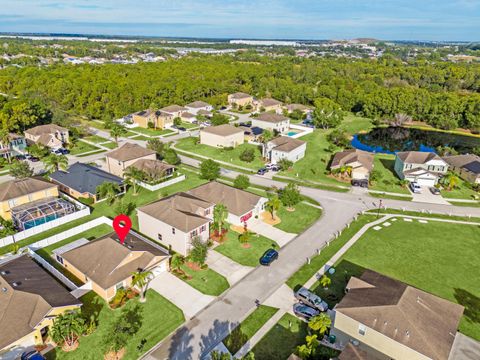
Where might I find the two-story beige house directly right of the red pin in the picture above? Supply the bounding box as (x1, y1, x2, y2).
(137, 192, 214, 256)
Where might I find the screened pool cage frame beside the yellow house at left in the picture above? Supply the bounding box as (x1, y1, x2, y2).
(12, 198, 77, 231)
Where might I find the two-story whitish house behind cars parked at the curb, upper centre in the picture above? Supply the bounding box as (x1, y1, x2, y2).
(264, 136, 307, 164)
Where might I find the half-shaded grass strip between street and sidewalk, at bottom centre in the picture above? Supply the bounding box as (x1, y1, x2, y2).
(223, 305, 278, 354)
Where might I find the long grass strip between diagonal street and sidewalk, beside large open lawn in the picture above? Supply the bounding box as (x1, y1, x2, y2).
(287, 215, 375, 290)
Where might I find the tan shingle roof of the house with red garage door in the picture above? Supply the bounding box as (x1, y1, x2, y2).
(189, 181, 261, 216)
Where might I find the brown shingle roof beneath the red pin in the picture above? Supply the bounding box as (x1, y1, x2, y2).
(61, 233, 168, 289)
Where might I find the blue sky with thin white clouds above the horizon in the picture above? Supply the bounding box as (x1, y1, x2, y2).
(0, 0, 480, 41)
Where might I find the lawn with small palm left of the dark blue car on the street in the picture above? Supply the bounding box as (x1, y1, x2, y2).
(214, 230, 278, 267)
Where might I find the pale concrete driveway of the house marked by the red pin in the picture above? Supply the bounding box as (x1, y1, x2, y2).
(149, 271, 215, 319)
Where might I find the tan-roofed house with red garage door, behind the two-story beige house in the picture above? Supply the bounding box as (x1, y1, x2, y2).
(188, 181, 267, 225)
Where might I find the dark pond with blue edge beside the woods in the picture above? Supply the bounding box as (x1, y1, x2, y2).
(351, 127, 480, 154)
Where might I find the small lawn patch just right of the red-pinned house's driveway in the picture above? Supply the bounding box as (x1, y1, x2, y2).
(179, 265, 230, 296)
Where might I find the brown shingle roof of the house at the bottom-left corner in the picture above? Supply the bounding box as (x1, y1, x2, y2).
(0, 255, 81, 349)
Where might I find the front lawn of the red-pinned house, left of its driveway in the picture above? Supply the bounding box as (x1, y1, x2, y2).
(47, 289, 185, 360)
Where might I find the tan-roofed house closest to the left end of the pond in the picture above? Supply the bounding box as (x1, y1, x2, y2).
(330, 149, 374, 181)
